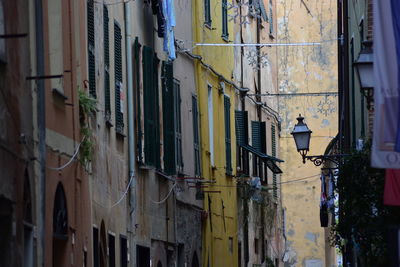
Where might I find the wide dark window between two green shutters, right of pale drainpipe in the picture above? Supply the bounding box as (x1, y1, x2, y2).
(143, 46, 160, 168)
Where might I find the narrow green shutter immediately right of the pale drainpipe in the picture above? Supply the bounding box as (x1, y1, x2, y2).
(134, 37, 143, 163)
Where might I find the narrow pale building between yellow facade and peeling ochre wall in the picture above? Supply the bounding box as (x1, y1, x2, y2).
(232, 1, 285, 266)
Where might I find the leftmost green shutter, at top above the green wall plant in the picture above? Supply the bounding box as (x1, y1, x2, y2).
(86, 0, 96, 98)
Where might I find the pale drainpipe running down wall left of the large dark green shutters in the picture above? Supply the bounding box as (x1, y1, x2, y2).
(125, 2, 136, 241)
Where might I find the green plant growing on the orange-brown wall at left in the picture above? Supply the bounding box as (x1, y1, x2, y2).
(78, 90, 97, 169)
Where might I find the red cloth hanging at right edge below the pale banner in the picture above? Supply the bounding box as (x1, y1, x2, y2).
(383, 169, 400, 206)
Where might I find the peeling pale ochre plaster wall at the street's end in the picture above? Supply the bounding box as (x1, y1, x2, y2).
(277, 0, 338, 266)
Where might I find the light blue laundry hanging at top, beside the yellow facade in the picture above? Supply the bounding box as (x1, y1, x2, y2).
(162, 0, 176, 60)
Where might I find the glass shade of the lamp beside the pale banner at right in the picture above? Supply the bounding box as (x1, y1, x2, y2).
(354, 50, 374, 88)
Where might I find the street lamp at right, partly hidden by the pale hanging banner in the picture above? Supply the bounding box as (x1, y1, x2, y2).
(353, 41, 374, 109)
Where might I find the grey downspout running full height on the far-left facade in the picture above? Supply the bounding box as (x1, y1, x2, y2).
(35, 0, 46, 266)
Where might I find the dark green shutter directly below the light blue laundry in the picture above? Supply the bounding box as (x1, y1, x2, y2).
(162, 62, 176, 174)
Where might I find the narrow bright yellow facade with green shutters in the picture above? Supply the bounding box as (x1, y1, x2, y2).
(193, 0, 238, 267)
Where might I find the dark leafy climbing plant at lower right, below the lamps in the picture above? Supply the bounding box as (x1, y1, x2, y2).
(330, 142, 400, 266)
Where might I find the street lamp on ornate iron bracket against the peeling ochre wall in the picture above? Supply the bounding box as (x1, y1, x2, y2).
(291, 114, 346, 166)
